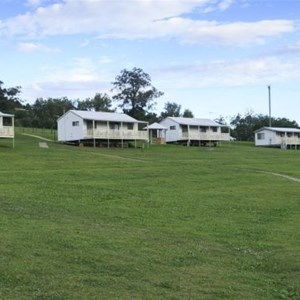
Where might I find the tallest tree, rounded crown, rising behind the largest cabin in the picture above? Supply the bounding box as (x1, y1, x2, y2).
(112, 68, 163, 120)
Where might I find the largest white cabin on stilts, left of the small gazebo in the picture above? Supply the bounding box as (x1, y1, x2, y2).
(57, 110, 148, 147)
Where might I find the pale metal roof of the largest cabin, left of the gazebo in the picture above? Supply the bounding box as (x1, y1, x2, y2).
(69, 110, 147, 123)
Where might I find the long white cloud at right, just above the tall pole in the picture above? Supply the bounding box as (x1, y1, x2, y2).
(159, 57, 300, 89)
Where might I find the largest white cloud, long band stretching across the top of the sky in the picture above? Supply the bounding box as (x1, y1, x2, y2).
(0, 0, 295, 45)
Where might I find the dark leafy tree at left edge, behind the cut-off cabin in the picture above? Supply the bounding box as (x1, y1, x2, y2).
(0, 81, 22, 113)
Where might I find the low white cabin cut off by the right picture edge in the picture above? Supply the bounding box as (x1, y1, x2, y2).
(254, 127, 300, 149)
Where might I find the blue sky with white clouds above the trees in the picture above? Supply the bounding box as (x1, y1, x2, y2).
(0, 0, 300, 126)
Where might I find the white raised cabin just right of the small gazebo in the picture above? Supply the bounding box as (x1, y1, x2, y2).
(160, 117, 230, 146)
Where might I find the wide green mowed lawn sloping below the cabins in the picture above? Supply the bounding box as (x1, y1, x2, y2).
(0, 134, 300, 299)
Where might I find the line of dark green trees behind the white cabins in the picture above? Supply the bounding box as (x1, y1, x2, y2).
(0, 68, 298, 141)
